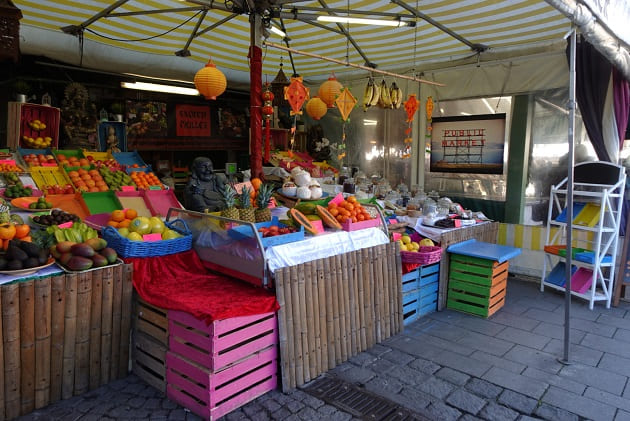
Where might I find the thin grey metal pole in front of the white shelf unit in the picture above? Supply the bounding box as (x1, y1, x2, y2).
(560, 27, 577, 364)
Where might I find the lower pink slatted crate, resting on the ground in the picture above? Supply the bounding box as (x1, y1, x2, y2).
(166, 345, 278, 420)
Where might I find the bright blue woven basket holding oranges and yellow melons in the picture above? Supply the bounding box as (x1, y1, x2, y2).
(101, 219, 192, 257)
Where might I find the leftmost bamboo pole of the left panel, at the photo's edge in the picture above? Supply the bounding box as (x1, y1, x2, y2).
(2, 284, 21, 419)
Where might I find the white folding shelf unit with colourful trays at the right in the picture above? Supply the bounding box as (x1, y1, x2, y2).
(540, 161, 626, 310)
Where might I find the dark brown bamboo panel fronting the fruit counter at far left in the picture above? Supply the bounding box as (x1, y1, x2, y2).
(0, 265, 133, 419)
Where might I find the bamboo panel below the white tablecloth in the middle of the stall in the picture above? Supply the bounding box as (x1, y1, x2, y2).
(275, 244, 402, 392)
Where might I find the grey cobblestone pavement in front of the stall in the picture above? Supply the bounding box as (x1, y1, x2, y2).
(18, 278, 630, 421)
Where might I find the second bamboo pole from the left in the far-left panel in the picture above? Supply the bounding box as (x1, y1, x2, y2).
(19, 280, 35, 414)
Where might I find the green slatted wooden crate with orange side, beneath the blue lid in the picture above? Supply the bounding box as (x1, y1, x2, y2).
(446, 254, 509, 317)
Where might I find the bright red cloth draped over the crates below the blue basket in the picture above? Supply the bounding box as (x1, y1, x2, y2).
(125, 250, 280, 323)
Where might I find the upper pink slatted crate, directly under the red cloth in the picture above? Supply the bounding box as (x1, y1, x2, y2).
(168, 311, 278, 372)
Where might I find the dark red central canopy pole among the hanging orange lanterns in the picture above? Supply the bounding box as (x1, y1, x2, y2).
(249, 13, 263, 178)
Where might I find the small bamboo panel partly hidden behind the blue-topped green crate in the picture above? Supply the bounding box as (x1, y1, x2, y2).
(437, 222, 499, 311)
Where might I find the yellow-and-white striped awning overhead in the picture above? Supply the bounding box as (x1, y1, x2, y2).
(9, 0, 630, 83)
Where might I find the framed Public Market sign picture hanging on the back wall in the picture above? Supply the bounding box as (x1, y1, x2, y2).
(430, 114, 505, 174)
